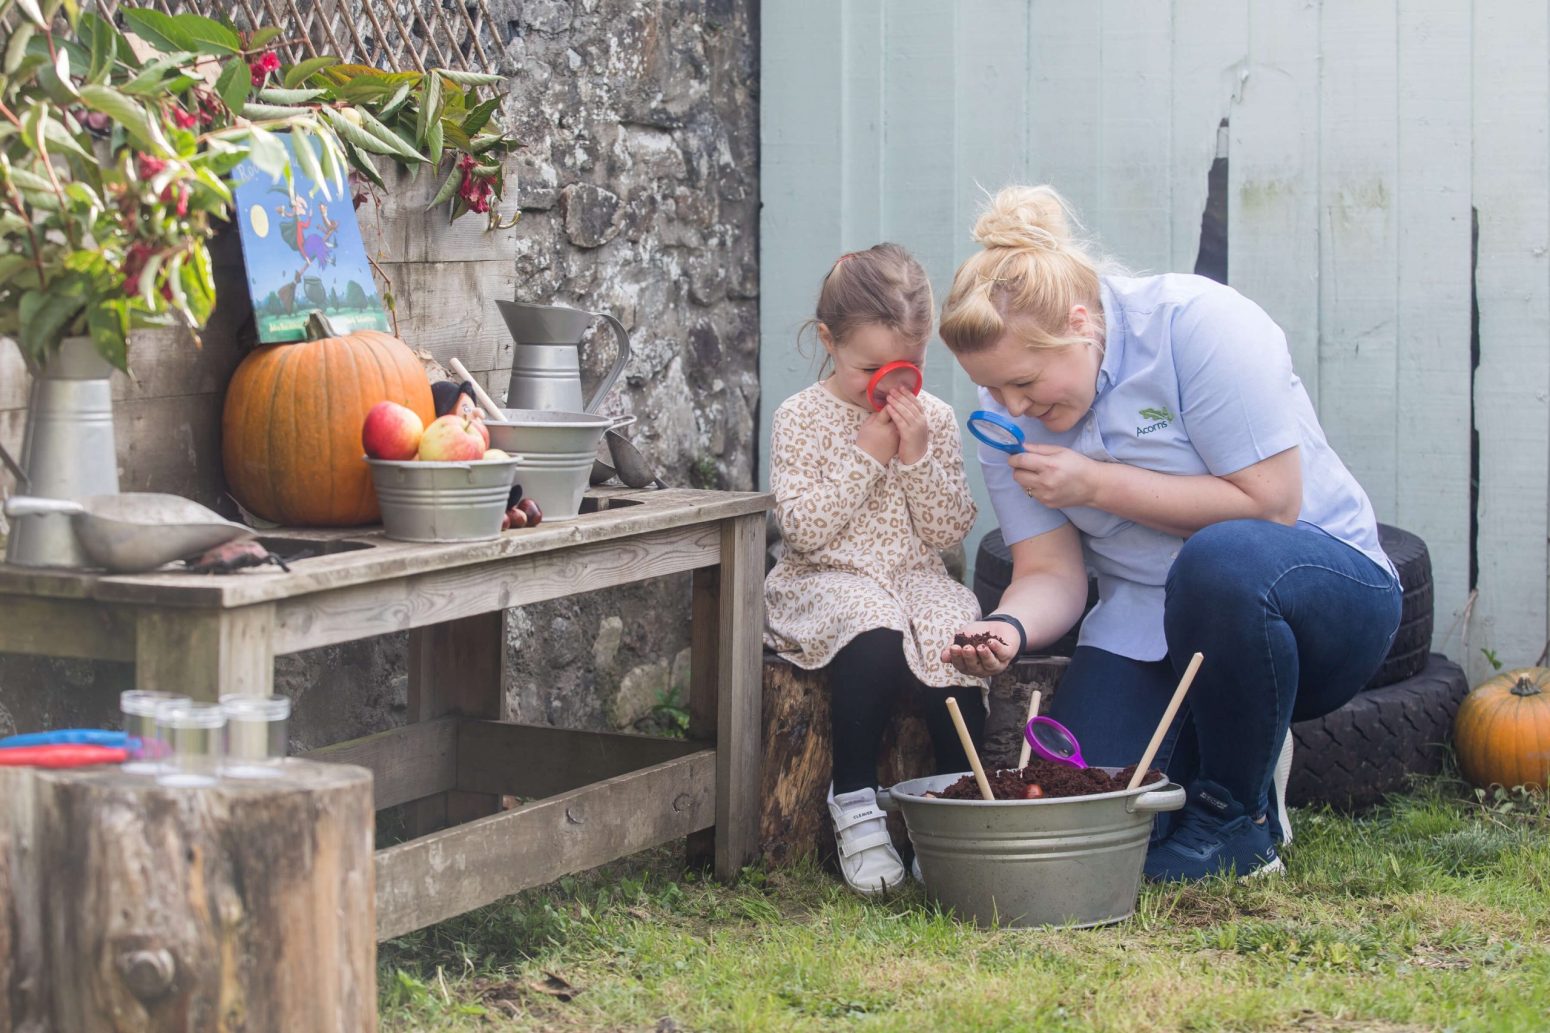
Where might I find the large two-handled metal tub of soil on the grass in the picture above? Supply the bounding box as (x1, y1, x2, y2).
(877, 768, 1184, 928)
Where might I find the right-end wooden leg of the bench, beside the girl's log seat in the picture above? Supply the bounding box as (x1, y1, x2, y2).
(688, 513, 764, 879)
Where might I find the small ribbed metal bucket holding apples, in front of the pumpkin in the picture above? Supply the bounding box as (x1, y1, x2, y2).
(366, 458, 516, 541)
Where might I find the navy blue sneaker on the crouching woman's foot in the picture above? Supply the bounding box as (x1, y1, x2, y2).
(1142, 779, 1287, 883)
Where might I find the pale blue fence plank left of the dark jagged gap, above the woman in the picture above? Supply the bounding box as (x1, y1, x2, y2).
(1166, 0, 1249, 273)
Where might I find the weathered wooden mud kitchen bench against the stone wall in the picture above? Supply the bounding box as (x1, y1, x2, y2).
(0, 489, 772, 938)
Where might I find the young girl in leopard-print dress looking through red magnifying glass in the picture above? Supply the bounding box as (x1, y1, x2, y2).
(764, 244, 986, 895)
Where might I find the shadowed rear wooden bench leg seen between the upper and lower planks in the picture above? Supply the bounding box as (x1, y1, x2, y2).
(408, 610, 505, 836)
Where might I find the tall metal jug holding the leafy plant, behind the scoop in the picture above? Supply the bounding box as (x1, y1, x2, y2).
(5, 337, 118, 566)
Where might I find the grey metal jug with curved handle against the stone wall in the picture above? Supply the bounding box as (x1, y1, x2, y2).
(494, 301, 629, 413)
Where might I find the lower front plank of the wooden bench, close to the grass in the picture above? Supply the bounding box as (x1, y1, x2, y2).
(377, 749, 716, 940)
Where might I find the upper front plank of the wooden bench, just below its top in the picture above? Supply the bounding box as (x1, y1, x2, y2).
(274, 526, 718, 653)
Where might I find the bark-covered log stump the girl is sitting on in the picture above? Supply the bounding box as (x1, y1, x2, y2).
(760, 653, 930, 865)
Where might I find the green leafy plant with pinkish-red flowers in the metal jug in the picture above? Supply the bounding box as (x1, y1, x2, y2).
(0, 0, 513, 369)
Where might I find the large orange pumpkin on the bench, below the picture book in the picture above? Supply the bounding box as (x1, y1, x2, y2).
(220, 313, 436, 527)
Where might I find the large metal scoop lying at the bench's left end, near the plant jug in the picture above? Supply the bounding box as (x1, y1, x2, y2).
(5, 492, 254, 574)
